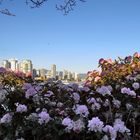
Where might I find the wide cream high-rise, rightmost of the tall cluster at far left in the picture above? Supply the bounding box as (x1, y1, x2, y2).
(19, 60, 33, 74)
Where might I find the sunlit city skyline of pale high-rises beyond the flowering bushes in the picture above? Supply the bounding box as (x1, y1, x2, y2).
(0, 58, 87, 81)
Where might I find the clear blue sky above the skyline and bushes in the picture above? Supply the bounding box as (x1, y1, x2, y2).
(0, 0, 140, 72)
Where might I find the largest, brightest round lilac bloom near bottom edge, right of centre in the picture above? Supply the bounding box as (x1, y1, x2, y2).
(88, 117, 104, 132)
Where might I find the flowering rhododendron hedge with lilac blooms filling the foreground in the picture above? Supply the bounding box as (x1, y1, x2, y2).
(0, 53, 140, 140)
